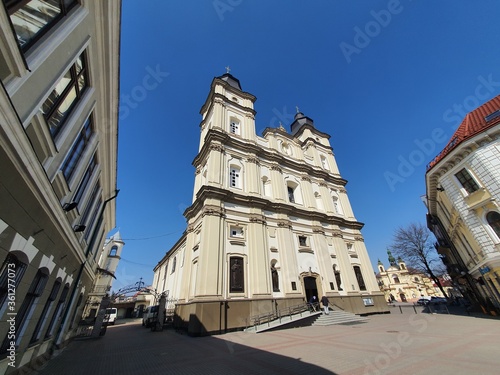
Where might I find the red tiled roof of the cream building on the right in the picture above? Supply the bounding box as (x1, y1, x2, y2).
(427, 95, 500, 171)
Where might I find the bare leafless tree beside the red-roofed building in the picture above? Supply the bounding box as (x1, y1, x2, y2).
(391, 223, 448, 298)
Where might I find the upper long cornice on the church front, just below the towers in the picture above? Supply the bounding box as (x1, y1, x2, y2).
(192, 129, 347, 186)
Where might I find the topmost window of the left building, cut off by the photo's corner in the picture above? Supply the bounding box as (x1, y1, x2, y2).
(4, 0, 78, 52)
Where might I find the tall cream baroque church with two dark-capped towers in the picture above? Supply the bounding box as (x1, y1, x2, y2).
(153, 73, 387, 335)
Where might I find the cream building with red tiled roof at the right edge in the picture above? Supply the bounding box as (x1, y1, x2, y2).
(426, 96, 500, 313)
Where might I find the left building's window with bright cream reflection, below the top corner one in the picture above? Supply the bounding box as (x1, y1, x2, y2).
(42, 53, 88, 138)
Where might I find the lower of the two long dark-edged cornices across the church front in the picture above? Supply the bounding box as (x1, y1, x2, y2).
(184, 185, 364, 232)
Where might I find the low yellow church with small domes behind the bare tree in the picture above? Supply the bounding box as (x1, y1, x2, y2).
(376, 251, 448, 302)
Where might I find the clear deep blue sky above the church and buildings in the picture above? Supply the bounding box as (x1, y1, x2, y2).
(112, 0, 500, 290)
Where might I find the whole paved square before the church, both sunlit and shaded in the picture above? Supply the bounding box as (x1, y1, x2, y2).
(35, 313, 500, 375)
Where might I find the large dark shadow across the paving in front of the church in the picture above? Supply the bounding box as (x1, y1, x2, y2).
(34, 321, 335, 375)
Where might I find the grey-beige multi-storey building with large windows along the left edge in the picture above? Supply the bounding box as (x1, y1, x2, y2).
(0, 0, 121, 374)
